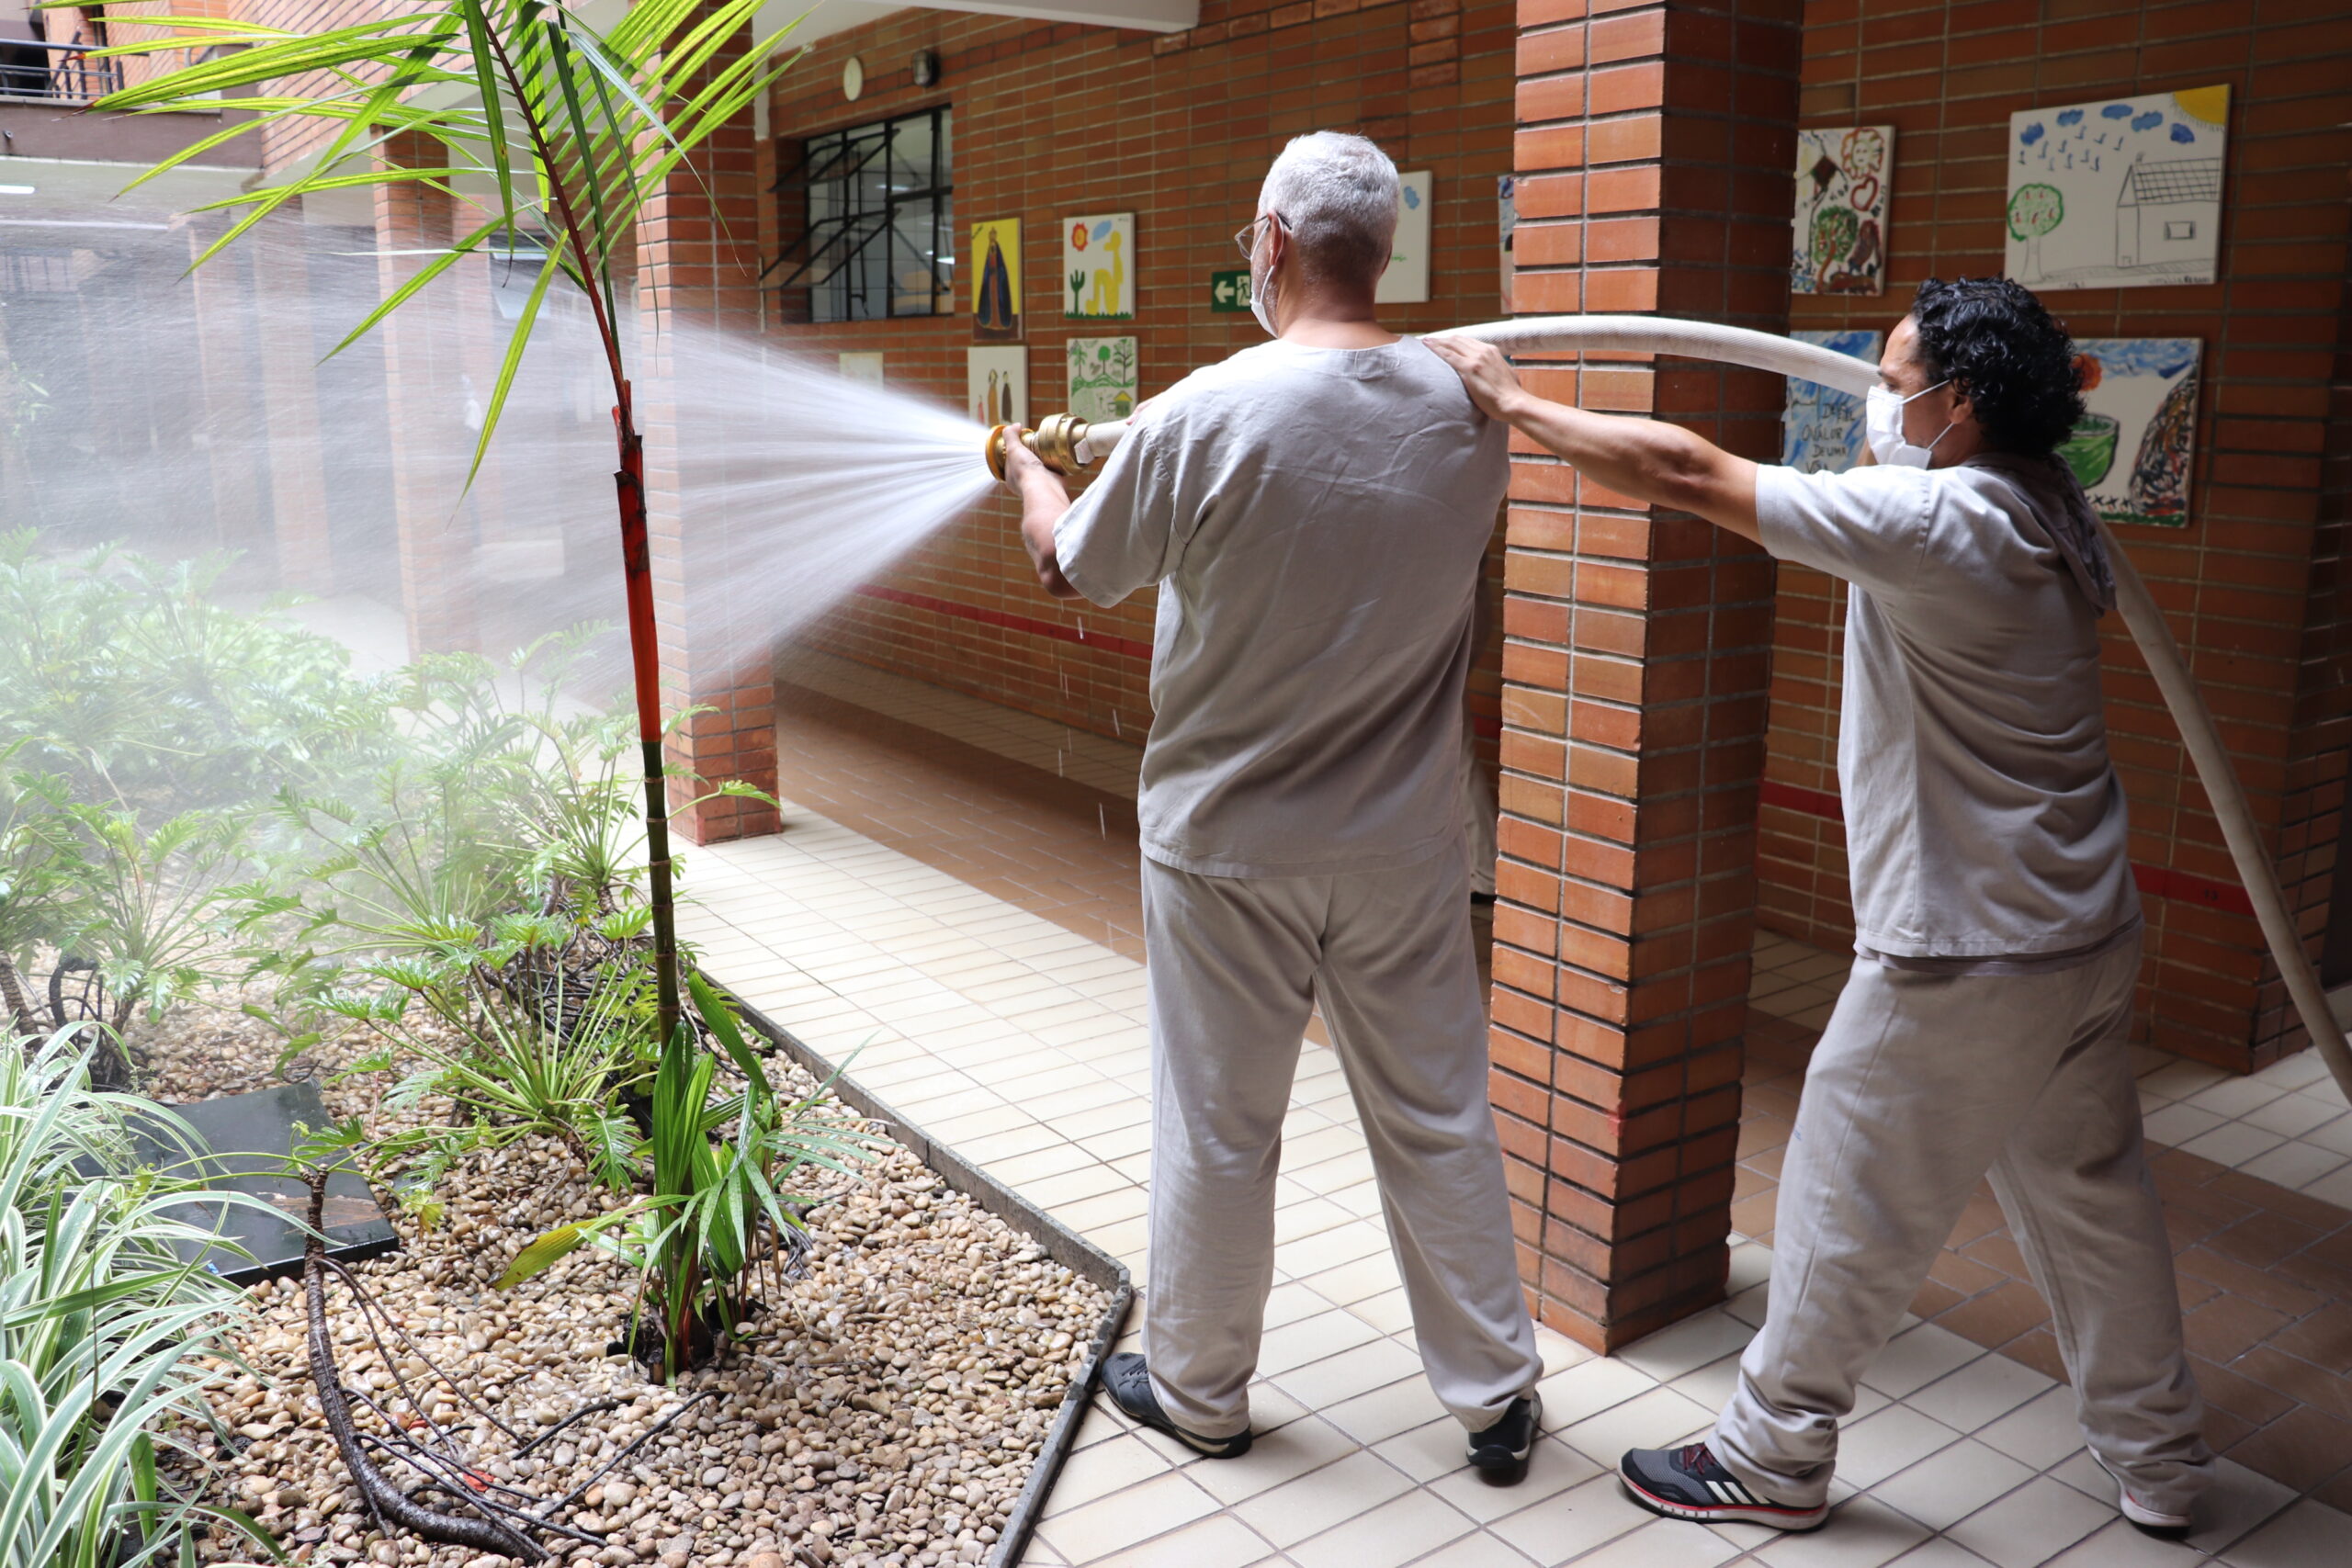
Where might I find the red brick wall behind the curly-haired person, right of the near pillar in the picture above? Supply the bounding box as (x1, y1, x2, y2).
(1761, 0, 2352, 1067)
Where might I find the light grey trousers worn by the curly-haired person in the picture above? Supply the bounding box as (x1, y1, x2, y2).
(1713, 942, 2213, 1512)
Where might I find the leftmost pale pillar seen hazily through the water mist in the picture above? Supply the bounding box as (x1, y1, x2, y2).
(252, 221, 334, 594)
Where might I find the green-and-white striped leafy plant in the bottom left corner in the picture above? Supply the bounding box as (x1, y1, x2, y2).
(0, 1030, 285, 1568)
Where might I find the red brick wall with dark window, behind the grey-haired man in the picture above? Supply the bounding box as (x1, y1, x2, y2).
(772, 0, 1515, 740)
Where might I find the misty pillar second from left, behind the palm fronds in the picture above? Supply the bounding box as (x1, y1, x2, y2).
(377, 136, 478, 656)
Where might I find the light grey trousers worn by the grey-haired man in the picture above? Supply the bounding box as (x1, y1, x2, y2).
(1143, 844, 1543, 1437)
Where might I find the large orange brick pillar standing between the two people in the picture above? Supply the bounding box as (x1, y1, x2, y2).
(1494, 0, 1802, 1349)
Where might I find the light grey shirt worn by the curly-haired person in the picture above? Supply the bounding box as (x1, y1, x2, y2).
(1757, 463, 2141, 968)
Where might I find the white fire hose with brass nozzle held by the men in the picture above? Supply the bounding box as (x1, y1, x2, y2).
(983, 315, 2352, 1100)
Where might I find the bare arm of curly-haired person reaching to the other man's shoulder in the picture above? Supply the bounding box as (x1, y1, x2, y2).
(1423, 336, 1757, 541)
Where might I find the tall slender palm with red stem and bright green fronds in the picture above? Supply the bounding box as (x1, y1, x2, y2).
(92, 0, 797, 1053)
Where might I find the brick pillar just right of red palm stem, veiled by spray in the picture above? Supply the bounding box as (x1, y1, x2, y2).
(633, 15, 781, 844)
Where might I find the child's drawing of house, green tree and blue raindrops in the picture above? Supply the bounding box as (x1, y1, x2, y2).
(2007, 85, 2230, 289)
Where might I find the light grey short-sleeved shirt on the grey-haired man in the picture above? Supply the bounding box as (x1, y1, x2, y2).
(1054, 339, 1510, 877)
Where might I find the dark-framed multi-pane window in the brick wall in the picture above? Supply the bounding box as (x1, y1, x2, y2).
(783, 106, 955, 322)
